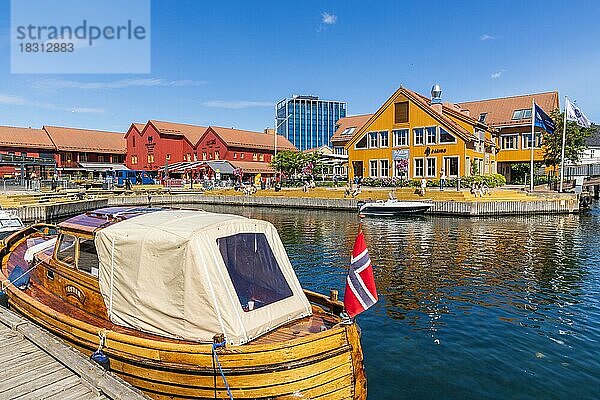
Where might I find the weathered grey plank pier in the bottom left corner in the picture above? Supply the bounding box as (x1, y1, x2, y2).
(0, 307, 148, 400)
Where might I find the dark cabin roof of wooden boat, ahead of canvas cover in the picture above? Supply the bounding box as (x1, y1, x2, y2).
(58, 207, 161, 235)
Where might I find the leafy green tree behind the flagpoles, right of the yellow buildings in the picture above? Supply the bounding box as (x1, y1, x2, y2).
(542, 109, 592, 171)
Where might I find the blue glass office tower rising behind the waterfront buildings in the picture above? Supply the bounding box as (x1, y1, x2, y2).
(275, 95, 346, 151)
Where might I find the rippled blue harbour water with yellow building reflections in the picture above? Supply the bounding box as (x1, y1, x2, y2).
(190, 204, 600, 399)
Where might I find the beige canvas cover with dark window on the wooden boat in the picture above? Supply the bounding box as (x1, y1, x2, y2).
(95, 211, 312, 345)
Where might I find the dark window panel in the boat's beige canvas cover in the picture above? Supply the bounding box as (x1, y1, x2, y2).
(217, 233, 292, 312)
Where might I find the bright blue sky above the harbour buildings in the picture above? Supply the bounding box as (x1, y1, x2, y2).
(0, 0, 600, 131)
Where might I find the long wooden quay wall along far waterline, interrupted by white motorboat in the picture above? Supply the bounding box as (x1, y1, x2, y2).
(10, 194, 579, 222)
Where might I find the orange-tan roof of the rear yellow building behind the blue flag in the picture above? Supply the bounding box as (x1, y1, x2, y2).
(458, 91, 558, 127)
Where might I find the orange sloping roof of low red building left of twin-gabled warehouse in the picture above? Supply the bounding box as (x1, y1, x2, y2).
(42, 126, 127, 154)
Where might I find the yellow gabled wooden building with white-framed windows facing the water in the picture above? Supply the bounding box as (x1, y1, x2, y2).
(345, 85, 497, 179)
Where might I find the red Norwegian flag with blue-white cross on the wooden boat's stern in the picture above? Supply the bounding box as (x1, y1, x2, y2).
(344, 229, 378, 318)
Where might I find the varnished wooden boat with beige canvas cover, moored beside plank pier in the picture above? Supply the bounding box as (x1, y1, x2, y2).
(0, 208, 367, 400)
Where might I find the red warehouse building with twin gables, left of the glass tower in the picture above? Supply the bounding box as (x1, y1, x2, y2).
(125, 120, 297, 172)
